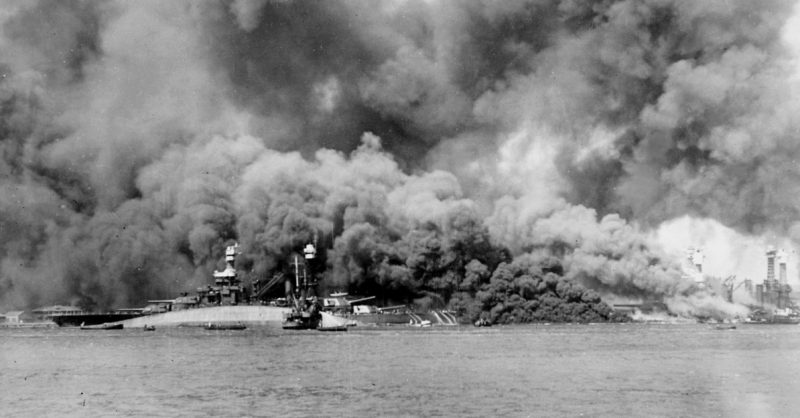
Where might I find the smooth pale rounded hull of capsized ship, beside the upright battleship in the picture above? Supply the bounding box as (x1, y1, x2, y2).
(117, 305, 291, 328)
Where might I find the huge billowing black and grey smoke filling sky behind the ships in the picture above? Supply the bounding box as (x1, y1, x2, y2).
(0, 0, 800, 321)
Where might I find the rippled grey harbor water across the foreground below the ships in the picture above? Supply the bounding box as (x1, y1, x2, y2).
(0, 324, 800, 417)
